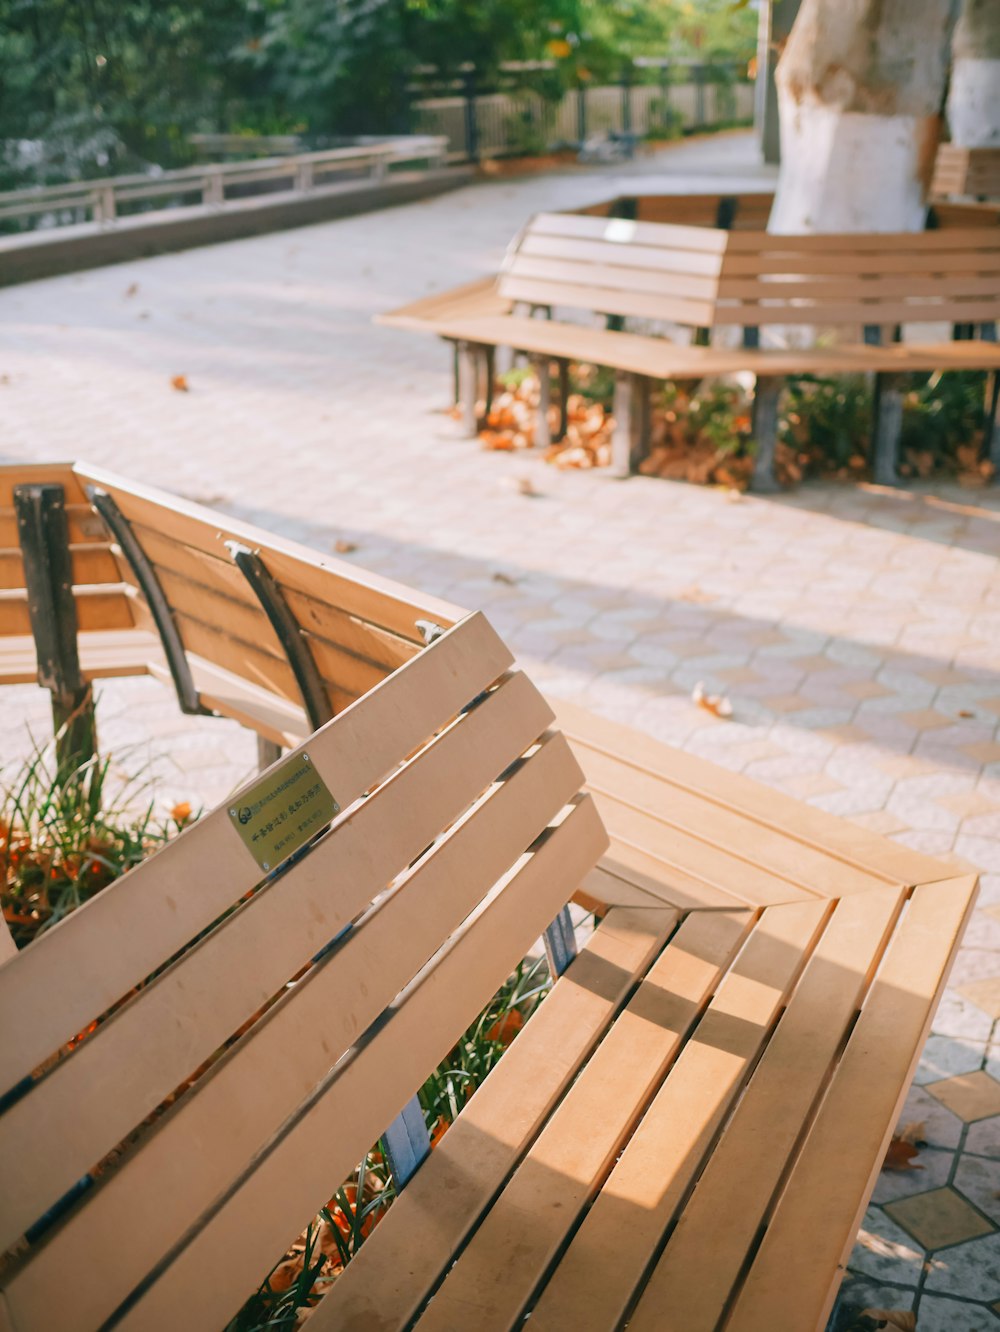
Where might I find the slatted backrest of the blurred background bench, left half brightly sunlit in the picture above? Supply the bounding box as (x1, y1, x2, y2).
(498, 213, 1000, 328)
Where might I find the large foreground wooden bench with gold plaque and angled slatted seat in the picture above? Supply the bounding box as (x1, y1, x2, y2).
(0, 466, 976, 1332)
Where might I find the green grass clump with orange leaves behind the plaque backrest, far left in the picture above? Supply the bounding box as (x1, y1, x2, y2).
(0, 737, 193, 947)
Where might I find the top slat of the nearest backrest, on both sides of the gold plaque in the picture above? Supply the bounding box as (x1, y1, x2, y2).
(0, 614, 511, 1088)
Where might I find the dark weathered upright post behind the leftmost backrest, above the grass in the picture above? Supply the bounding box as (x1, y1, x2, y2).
(13, 485, 97, 779)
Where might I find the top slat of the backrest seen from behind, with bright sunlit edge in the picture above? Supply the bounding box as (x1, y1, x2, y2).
(74, 468, 462, 643)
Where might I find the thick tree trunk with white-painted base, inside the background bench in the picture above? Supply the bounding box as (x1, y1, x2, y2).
(770, 0, 958, 234)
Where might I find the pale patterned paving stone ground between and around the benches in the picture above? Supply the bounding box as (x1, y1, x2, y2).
(0, 135, 1000, 1332)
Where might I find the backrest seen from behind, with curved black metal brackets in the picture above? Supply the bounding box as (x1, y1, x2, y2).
(0, 465, 461, 743)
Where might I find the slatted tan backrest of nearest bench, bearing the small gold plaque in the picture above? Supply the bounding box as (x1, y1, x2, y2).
(0, 614, 607, 1332)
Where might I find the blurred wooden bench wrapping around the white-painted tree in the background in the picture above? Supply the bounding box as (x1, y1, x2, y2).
(381, 203, 1000, 490)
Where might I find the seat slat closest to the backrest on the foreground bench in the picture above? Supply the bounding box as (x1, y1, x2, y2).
(324, 908, 678, 1332)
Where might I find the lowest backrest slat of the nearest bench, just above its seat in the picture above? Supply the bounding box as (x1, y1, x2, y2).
(109, 797, 605, 1332)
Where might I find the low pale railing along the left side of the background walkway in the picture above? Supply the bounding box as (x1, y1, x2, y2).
(0, 135, 447, 229)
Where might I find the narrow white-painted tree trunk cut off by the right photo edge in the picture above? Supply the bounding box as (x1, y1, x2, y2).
(948, 0, 1000, 148)
